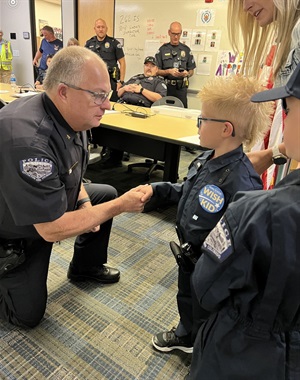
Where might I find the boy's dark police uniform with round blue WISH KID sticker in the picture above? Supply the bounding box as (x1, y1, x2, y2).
(151, 146, 262, 346)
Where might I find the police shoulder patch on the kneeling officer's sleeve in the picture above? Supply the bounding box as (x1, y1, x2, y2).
(20, 157, 54, 182)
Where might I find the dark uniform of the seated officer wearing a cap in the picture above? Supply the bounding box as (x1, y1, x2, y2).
(121, 74, 167, 107)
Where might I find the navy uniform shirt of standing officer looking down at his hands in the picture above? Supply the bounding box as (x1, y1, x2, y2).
(155, 42, 196, 80)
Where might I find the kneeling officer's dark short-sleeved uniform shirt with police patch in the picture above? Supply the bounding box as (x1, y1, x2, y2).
(0, 93, 88, 239)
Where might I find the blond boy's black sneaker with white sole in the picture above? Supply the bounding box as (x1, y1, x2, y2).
(152, 327, 193, 354)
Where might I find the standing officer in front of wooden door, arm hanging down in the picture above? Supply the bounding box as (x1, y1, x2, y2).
(85, 18, 126, 102)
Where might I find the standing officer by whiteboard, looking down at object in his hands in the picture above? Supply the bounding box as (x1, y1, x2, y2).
(155, 21, 196, 108)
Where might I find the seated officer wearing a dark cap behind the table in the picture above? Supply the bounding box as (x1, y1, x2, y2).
(118, 56, 167, 107)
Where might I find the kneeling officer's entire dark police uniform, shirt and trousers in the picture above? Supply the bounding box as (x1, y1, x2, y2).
(0, 93, 117, 326)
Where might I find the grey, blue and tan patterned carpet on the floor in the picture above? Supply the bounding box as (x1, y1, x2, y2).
(0, 152, 194, 380)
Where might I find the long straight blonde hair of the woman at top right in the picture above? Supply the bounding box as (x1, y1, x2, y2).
(227, 0, 300, 78)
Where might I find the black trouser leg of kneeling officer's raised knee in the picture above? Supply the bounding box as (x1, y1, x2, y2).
(72, 183, 117, 269)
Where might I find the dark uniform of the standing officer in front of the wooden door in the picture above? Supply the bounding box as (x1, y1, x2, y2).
(85, 36, 124, 102)
